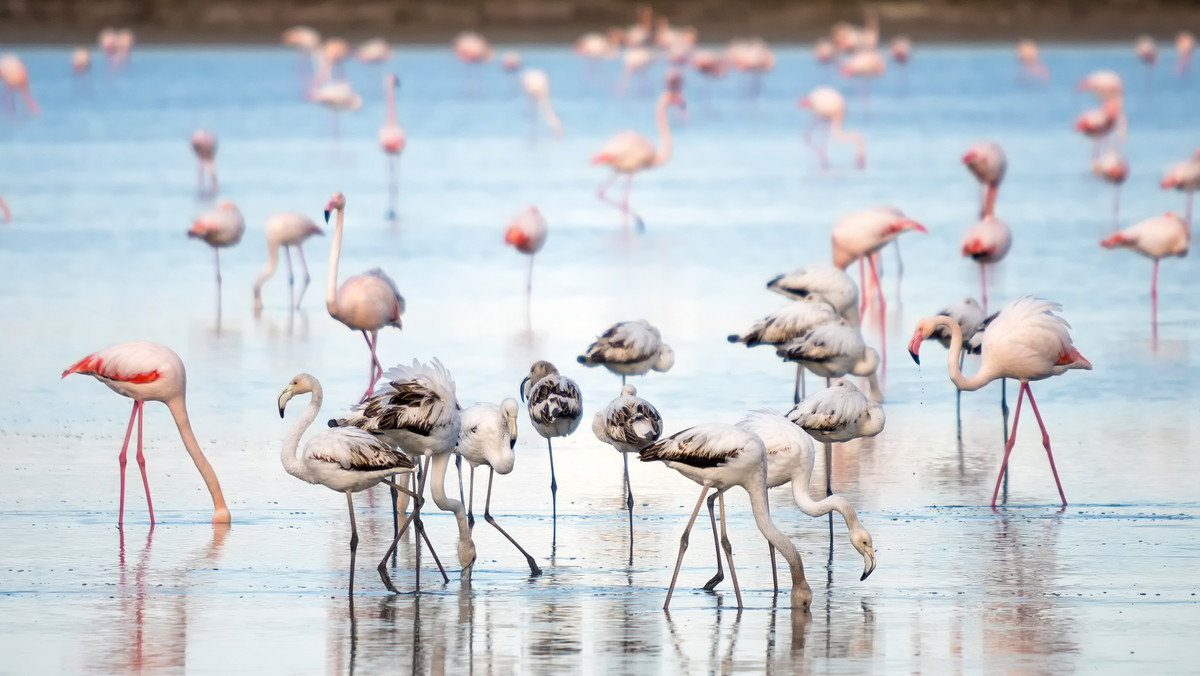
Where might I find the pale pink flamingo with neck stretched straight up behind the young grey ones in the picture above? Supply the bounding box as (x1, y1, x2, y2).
(325, 192, 404, 401)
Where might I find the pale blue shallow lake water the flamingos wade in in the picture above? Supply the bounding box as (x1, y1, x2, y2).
(0, 44, 1200, 674)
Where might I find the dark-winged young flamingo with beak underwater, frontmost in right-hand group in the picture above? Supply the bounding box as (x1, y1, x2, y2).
(637, 423, 812, 612)
